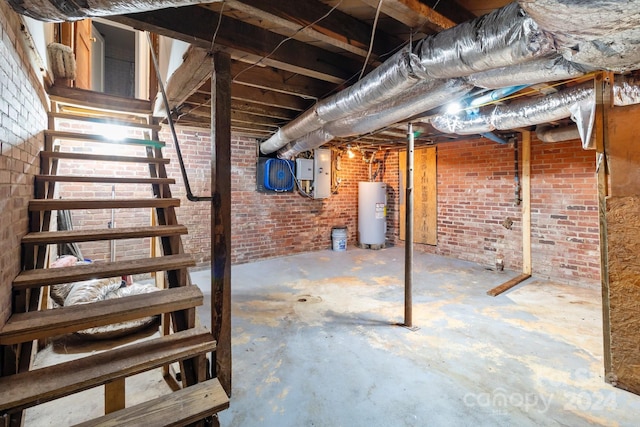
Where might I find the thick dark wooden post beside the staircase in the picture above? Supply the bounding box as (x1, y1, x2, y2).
(211, 52, 231, 396)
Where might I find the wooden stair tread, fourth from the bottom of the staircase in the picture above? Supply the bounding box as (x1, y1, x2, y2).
(13, 254, 195, 290)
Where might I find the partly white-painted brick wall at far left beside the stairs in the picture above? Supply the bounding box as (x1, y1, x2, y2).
(0, 2, 47, 326)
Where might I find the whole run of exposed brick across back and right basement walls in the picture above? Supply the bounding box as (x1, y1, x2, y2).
(56, 127, 599, 285)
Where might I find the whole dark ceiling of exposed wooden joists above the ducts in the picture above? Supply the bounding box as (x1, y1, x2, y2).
(109, 0, 509, 144)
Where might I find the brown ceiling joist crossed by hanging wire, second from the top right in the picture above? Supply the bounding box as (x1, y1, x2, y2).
(218, 0, 403, 57)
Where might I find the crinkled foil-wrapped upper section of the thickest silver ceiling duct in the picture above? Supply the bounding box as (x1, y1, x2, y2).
(416, 3, 555, 78)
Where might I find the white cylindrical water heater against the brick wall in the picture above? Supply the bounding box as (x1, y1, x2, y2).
(358, 182, 387, 245)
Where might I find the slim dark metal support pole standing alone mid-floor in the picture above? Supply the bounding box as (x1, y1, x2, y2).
(404, 123, 414, 328)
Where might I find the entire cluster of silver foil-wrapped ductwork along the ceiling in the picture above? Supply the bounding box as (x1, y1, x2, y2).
(260, 0, 640, 158)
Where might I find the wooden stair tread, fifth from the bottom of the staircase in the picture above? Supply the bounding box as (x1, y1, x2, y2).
(22, 225, 188, 245)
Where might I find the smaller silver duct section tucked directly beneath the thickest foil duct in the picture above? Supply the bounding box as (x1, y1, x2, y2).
(467, 54, 591, 89)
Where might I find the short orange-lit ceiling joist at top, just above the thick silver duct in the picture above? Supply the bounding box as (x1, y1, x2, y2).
(362, 0, 456, 33)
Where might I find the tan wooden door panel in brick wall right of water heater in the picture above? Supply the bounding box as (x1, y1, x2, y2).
(399, 147, 438, 245)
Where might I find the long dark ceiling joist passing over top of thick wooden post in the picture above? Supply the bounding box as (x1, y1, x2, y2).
(109, 6, 362, 83)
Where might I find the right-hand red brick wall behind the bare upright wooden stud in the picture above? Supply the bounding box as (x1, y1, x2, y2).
(385, 138, 600, 286)
